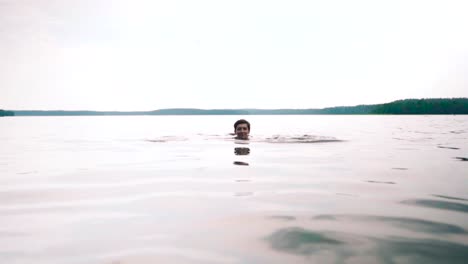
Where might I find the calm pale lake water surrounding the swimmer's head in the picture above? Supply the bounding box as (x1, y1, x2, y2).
(0, 116, 468, 264)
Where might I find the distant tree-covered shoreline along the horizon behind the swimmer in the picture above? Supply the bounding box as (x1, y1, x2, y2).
(0, 98, 468, 116)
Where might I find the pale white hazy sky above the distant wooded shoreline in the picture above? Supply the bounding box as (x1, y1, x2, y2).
(0, 0, 468, 111)
